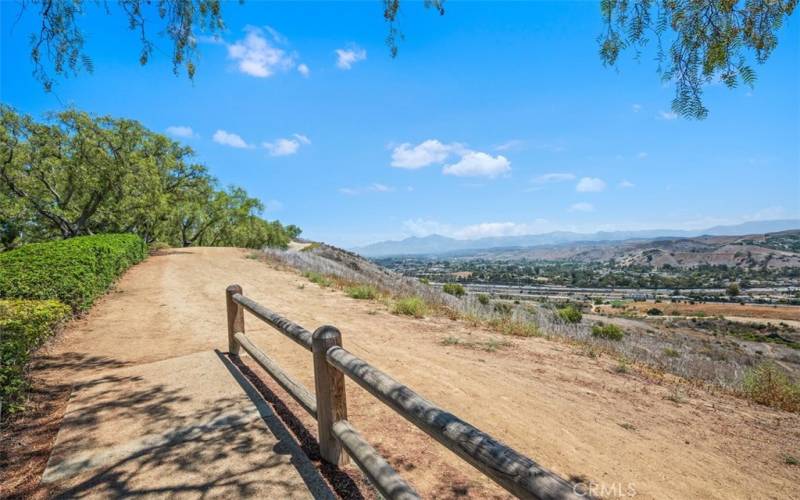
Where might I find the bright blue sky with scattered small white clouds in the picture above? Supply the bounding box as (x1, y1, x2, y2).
(0, 0, 800, 246)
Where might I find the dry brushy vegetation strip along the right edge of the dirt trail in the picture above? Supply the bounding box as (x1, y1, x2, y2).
(266, 244, 800, 411)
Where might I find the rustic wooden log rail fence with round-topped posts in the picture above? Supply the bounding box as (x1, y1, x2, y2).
(225, 285, 588, 500)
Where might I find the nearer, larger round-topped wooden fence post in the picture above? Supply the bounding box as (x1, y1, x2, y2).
(311, 325, 348, 465)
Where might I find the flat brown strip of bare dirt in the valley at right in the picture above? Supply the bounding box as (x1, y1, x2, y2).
(596, 300, 800, 322)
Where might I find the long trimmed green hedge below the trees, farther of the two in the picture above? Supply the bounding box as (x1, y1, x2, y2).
(0, 234, 147, 311)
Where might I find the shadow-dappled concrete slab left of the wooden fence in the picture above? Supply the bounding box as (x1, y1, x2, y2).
(29, 353, 335, 498)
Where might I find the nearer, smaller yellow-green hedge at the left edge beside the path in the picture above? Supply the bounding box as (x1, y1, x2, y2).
(0, 299, 71, 415)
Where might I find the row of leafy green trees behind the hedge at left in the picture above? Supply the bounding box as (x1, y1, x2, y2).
(0, 105, 300, 252)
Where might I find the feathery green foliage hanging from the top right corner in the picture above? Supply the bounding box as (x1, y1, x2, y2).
(599, 0, 797, 119)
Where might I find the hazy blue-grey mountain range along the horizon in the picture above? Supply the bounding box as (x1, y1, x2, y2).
(352, 219, 800, 257)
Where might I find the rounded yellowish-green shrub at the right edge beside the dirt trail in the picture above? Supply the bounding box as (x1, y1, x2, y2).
(742, 361, 800, 412)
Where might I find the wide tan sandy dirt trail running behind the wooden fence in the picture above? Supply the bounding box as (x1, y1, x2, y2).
(3, 248, 800, 499)
